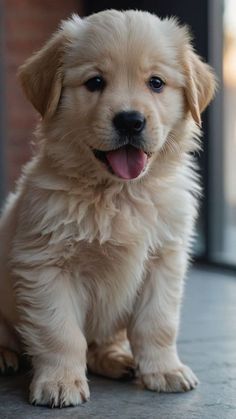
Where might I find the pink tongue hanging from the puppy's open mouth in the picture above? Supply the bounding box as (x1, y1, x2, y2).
(106, 146, 147, 179)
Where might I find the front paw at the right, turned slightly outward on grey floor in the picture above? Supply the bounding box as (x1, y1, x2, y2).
(140, 365, 198, 393)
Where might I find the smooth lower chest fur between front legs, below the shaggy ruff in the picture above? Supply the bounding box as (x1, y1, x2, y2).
(73, 238, 146, 340)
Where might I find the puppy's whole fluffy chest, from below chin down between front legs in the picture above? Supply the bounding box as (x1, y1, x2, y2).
(12, 156, 195, 342)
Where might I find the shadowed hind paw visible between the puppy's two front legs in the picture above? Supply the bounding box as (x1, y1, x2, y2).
(87, 332, 134, 379)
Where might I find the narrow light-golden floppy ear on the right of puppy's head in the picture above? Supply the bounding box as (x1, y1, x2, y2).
(184, 49, 216, 126)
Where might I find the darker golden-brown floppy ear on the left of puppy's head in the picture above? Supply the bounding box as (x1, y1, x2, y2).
(18, 32, 64, 118)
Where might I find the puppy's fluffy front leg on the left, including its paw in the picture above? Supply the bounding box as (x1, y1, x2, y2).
(16, 267, 89, 407)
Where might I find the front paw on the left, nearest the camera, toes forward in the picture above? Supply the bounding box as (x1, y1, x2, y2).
(30, 368, 89, 407)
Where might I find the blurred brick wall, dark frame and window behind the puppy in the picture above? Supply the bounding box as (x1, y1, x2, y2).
(0, 0, 236, 269)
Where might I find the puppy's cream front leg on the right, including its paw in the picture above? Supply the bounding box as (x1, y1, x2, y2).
(128, 251, 198, 392)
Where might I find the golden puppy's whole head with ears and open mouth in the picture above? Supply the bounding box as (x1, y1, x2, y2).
(19, 10, 215, 181)
